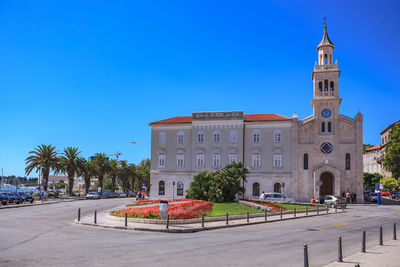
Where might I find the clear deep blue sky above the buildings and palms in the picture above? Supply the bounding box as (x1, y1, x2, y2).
(0, 0, 400, 176)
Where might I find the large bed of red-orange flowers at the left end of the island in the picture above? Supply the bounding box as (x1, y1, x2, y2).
(112, 199, 213, 220)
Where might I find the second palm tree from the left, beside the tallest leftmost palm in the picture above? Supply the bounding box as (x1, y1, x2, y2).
(57, 147, 82, 195)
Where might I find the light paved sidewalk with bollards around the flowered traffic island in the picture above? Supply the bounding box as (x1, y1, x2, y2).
(75, 207, 346, 233)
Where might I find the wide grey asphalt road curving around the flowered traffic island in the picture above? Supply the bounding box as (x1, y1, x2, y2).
(0, 199, 400, 267)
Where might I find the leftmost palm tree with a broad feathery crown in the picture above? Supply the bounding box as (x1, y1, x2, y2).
(25, 144, 60, 192)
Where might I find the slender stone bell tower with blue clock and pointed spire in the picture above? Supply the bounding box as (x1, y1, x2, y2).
(311, 22, 341, 124)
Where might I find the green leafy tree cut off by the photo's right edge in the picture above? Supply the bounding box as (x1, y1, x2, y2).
(383, 122, 400, 179)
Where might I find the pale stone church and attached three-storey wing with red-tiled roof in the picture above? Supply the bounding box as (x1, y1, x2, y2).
(149, 23, 363, 203)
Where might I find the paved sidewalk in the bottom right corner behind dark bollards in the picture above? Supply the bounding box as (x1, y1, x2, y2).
(324, 240, 400, 267)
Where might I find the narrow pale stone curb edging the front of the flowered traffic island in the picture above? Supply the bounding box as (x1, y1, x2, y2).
(74, 210, 347, 233)
